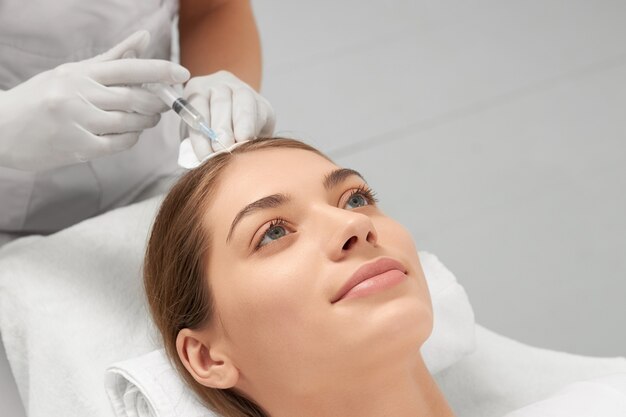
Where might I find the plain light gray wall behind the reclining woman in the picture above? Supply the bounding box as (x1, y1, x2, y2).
(253, 0, 626, 356)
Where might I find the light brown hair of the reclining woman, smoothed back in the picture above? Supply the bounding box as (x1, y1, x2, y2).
(143, 137, 332, 417)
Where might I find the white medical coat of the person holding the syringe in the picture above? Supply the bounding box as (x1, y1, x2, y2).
(0, 0, 179, 233)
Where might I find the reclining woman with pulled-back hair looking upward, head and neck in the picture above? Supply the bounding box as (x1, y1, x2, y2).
(144, 138, 453, 417)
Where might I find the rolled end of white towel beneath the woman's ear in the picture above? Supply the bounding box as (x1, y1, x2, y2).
(105, 349, 218, 417)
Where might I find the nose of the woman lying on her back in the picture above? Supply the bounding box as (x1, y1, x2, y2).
(326, 209, 378, 261)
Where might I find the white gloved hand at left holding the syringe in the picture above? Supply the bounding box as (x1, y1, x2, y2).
(0, 31, 189, 171)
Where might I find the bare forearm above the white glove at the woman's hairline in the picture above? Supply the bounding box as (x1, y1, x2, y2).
(179, 0, 261, 91)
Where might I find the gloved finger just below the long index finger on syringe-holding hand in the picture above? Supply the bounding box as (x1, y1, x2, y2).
(89, 85, 169, 116)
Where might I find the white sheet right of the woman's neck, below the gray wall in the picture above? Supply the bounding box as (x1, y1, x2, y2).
(435, 325, 626, 417)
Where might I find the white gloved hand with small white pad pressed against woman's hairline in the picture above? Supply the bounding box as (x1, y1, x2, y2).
(178, 71, 275, 168)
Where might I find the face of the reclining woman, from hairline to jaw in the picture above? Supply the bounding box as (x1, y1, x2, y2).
(200, 148, 432, 397)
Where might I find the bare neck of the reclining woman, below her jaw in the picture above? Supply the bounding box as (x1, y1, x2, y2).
(267, 355, 454, 417)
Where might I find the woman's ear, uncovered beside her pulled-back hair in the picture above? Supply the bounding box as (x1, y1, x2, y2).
(176, 329, 239, 389)
